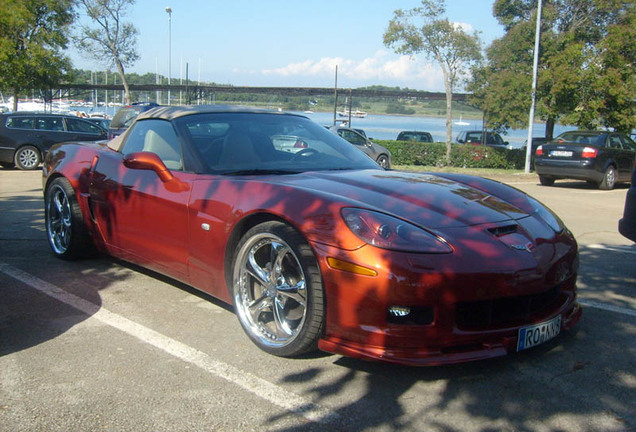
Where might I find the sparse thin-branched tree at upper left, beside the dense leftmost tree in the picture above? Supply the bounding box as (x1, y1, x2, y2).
(76, 0, 139, 103)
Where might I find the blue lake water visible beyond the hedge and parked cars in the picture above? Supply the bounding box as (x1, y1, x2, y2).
(302, 112, 576, 148)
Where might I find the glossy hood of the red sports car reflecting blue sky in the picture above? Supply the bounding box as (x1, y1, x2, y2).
(277, 170, 529, 229)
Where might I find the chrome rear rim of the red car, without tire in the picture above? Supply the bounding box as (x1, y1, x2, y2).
(46, 184, 73, 254)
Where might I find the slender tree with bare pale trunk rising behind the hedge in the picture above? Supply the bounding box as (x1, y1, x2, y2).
(384, 0, 481, 160)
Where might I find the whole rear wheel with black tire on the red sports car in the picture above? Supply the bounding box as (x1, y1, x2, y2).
(44, 177, 93, 260)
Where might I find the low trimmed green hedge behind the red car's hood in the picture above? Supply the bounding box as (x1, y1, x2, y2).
(375, 140, 525, 169)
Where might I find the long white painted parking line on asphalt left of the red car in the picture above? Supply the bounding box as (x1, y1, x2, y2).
(0, 263, 338, 423)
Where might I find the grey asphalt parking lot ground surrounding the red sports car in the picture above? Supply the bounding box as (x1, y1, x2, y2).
(0, 169, 636, 432)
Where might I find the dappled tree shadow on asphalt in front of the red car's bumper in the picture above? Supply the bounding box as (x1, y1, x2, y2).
(272, 243, 636, 432)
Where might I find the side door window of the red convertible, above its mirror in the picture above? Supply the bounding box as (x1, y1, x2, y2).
(121, 119, 183, 170)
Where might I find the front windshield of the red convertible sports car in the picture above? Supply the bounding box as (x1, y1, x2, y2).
(175, 113, 381, 175)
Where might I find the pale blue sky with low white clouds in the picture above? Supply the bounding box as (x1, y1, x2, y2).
(69, 0, 504, 91)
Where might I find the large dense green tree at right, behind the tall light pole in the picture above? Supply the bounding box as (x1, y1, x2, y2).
(468, 0, 636, 139)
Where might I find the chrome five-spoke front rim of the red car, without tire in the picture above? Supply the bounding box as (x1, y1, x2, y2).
(233, 233, 307, 348)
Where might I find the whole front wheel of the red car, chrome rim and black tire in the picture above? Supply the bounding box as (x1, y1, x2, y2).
(231, 221, 324, 357)
